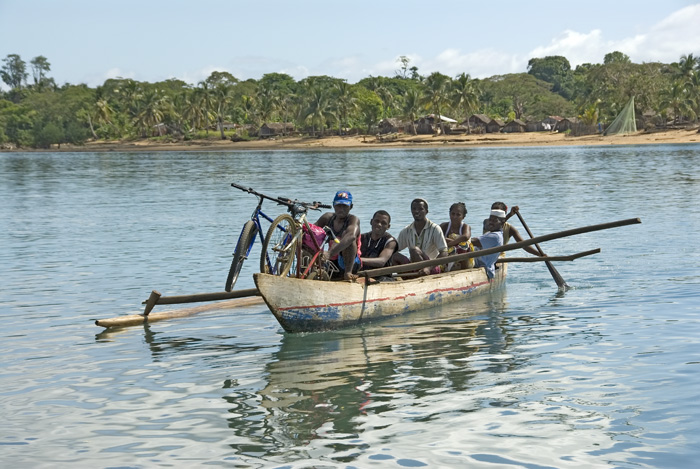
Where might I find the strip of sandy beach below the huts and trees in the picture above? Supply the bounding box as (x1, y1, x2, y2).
(0, 128, 700, 152)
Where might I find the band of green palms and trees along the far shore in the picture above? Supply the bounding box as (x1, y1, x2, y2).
(0, 51, 700, 148)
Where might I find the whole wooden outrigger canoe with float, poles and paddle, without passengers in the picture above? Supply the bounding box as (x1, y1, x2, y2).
(95, 218, 641, 332)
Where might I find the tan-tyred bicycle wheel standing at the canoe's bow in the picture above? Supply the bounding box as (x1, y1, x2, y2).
(260, 213, 297, 276)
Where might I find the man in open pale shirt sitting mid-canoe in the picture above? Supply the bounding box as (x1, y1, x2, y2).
(394, 199, 447, 275)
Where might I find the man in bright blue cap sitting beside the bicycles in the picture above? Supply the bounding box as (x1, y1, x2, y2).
(316, 191, 361, 280)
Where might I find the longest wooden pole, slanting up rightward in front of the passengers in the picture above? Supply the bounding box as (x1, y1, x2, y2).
(361, 218, 642, 277)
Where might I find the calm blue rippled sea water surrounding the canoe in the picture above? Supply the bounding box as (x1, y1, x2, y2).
(0, 145, 700, 468)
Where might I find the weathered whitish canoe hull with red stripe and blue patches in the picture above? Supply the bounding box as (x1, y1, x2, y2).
(253, 264, 508, 332)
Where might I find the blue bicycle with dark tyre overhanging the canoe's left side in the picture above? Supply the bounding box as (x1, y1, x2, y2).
(224, 182, 331, 292)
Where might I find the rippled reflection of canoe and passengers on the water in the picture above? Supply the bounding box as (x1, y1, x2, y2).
(228, 288, 509, 456)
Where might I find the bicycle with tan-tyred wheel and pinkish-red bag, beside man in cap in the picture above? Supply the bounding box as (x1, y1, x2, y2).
(260, 199, 339, 280)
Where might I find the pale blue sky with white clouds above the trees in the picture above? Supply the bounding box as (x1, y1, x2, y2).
(0, 0, 700, 90)
